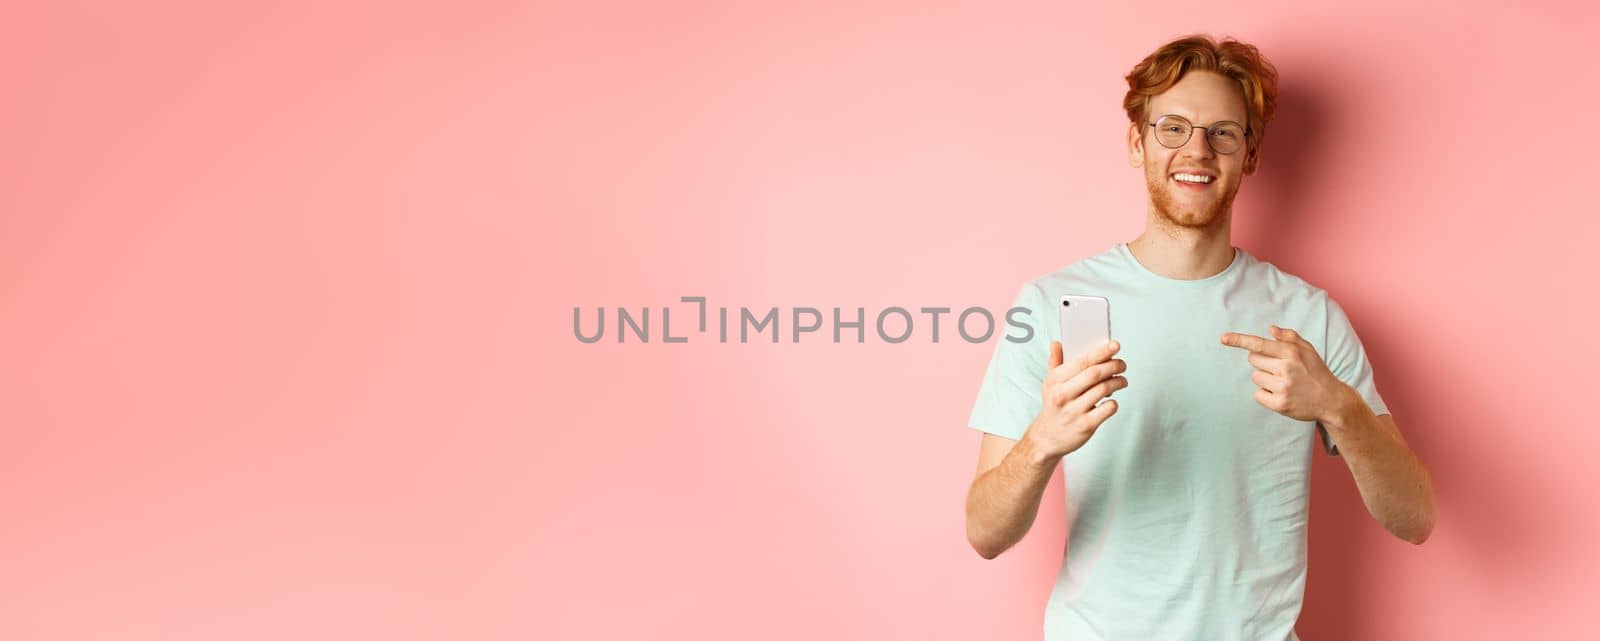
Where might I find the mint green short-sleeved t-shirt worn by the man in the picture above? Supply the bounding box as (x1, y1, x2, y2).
(968, 243, 1389, 641)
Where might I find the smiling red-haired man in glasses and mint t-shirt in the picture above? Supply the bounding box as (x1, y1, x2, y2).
(966, 37, 1434, 641)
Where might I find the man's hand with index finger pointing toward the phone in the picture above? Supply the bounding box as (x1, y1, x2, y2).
(1222, 324, 1349, 422)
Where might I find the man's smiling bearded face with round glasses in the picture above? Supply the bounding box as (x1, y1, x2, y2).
(1128, 72, 1259, 229)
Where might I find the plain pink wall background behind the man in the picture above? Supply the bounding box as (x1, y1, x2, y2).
(0, 2, 1600, 641)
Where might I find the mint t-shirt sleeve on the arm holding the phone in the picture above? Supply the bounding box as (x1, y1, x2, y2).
(966, 283, 1051, 441)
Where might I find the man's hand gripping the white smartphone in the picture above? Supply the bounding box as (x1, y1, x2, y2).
(1022, 340, 1128, 459)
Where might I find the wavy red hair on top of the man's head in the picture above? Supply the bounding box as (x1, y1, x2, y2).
(1122, 34, 1278, 147)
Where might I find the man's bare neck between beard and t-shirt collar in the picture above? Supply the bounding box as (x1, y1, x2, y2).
(1128, 211, 1234, 280)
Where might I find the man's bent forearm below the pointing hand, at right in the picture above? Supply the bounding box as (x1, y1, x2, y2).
(1322, 388, 1435, 543)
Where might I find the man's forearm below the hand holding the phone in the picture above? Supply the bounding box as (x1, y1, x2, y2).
(966, 435, 1061, 559)
